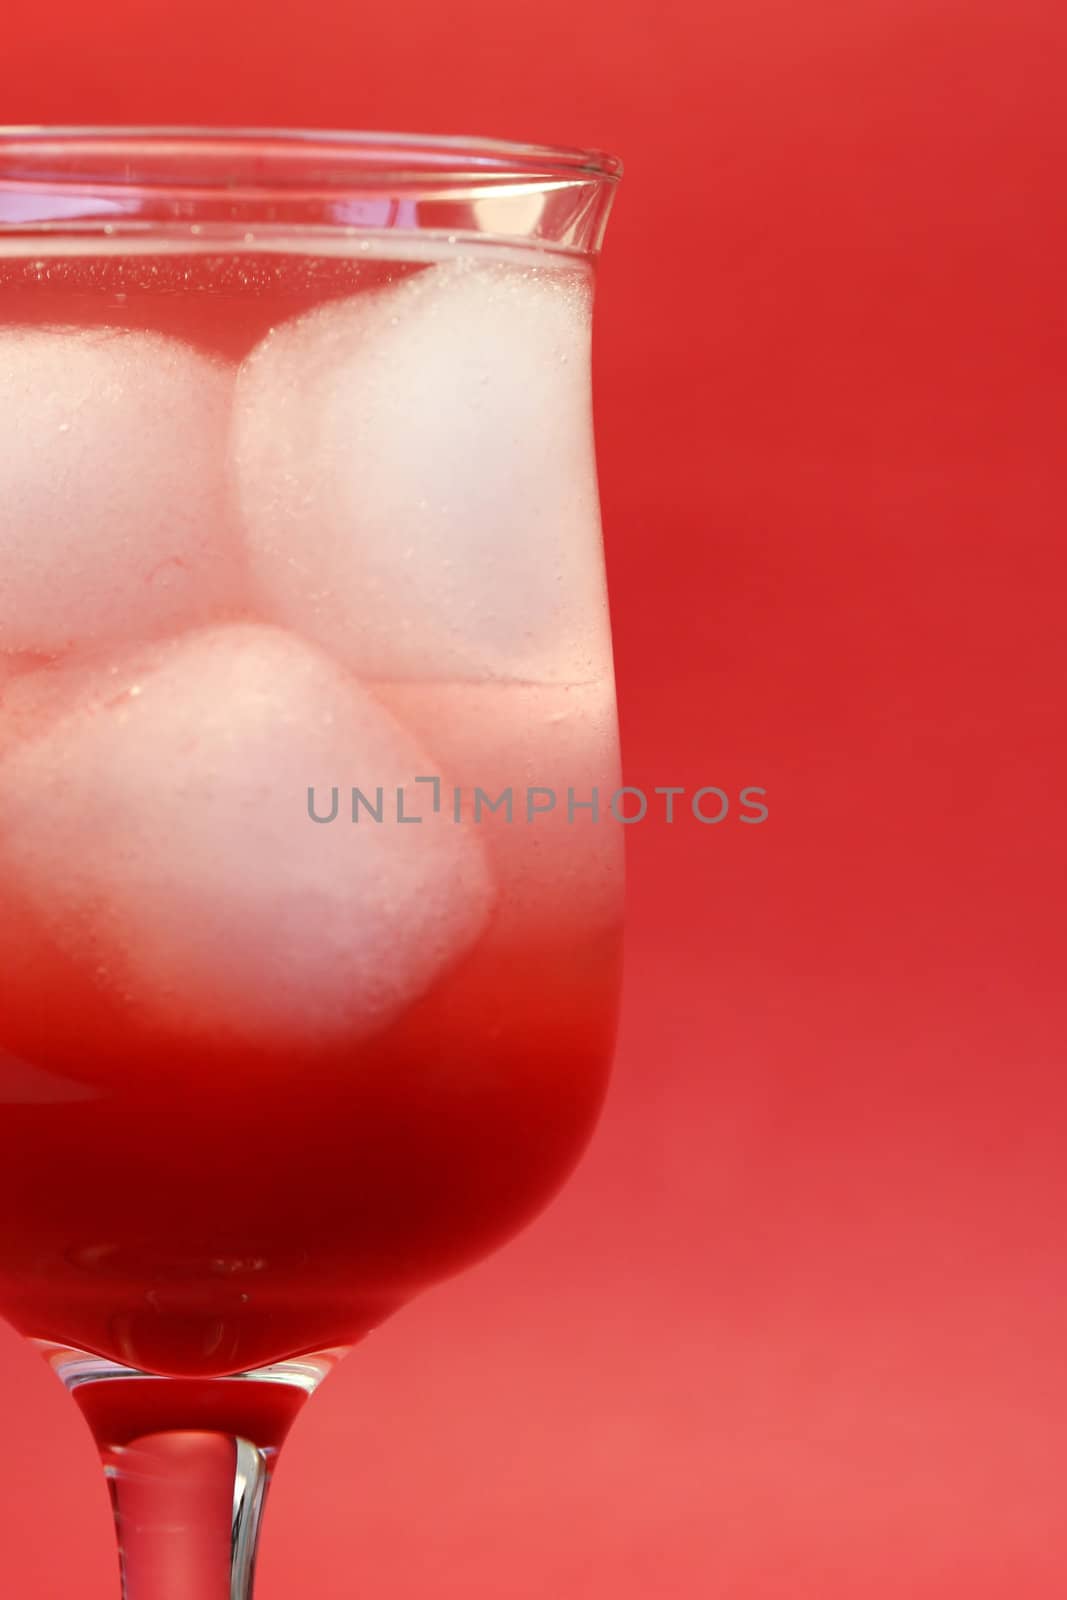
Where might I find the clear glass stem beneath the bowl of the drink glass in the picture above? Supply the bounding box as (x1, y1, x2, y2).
(32, 1339, 346, 1600)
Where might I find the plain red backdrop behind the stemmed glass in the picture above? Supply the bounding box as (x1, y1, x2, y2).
(0, 0, 1067, 1600)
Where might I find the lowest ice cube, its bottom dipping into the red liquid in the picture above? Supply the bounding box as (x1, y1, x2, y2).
(0, 624, 493, 1045)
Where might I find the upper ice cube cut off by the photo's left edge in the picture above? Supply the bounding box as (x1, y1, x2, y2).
(0, 328, 240, 653)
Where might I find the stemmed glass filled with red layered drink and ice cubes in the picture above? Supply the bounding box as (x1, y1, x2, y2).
(0, 128, 622, 1600)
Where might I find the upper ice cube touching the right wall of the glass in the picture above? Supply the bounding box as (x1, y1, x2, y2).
(234, 261, 609, 682)
